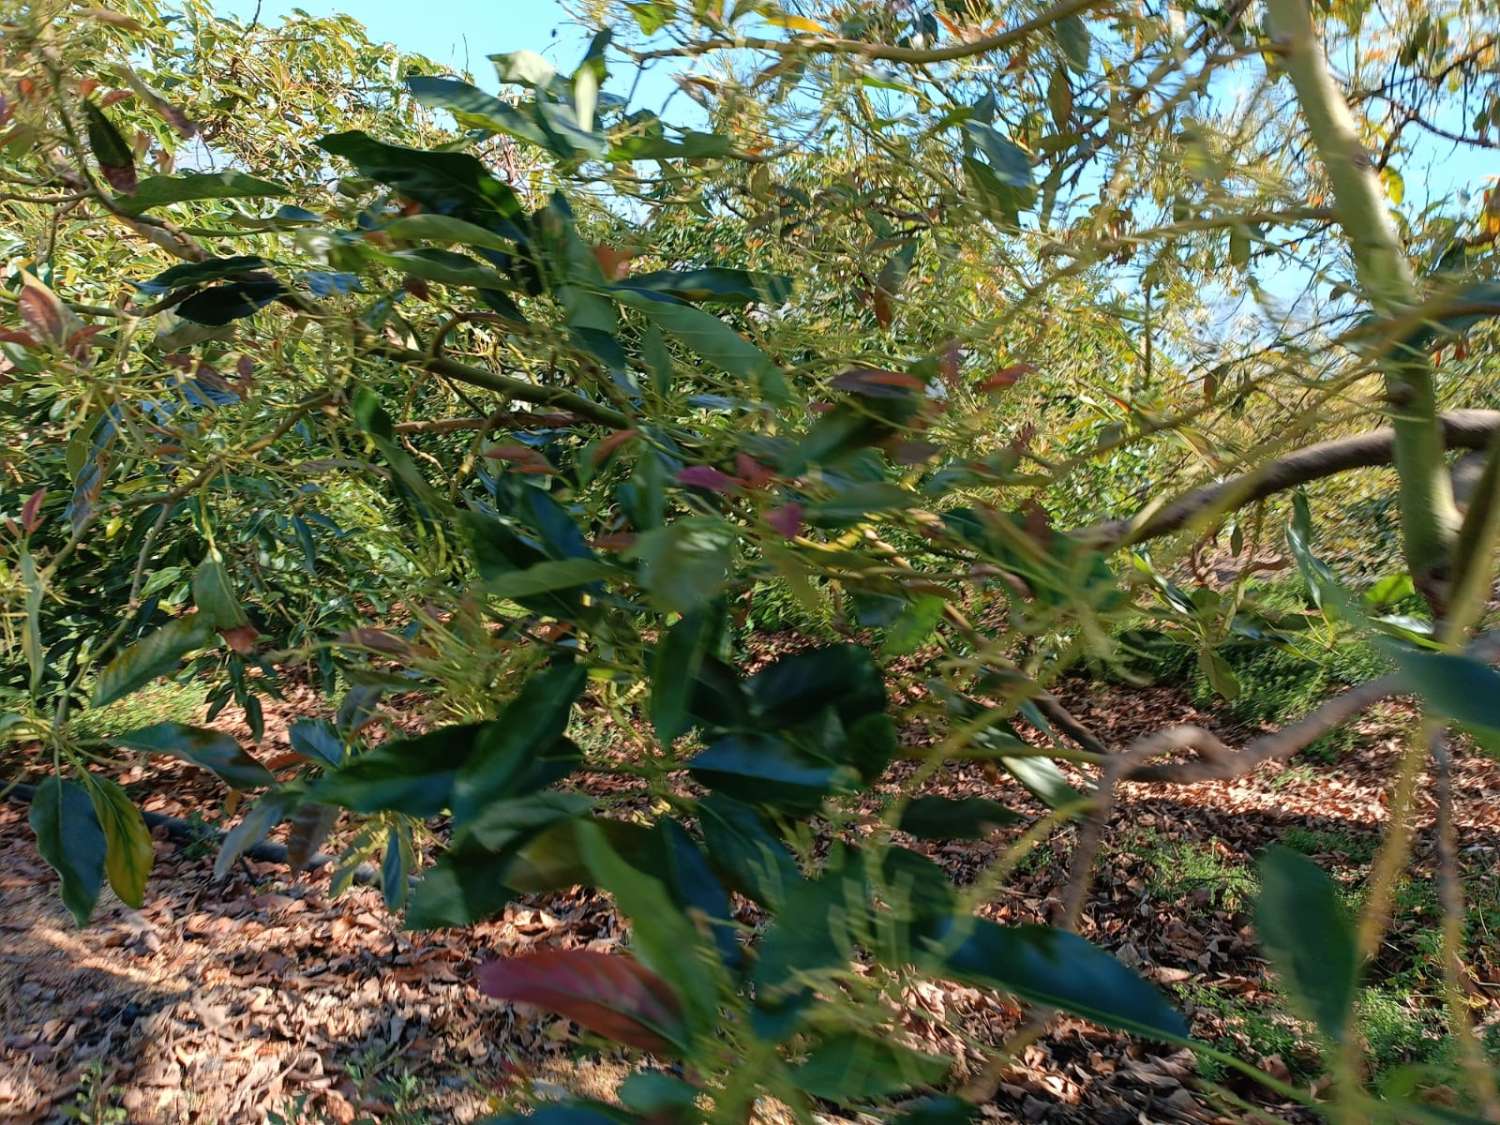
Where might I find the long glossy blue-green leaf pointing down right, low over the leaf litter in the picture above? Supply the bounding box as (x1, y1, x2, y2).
(924, 917, 1188, 1040)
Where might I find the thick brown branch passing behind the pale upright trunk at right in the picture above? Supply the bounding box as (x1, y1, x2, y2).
(1074, 410, 1500, 546)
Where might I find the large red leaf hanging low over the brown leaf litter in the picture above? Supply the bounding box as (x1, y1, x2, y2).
(479, 950, 687, 1053)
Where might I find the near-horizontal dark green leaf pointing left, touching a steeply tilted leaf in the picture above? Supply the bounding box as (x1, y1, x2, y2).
(309, 723, 488, 818)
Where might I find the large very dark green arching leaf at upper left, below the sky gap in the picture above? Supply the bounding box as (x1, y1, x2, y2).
(318, 129, 522, 236)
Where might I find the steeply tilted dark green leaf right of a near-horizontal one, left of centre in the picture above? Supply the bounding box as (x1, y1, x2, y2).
(450, 663, 588, 825)
